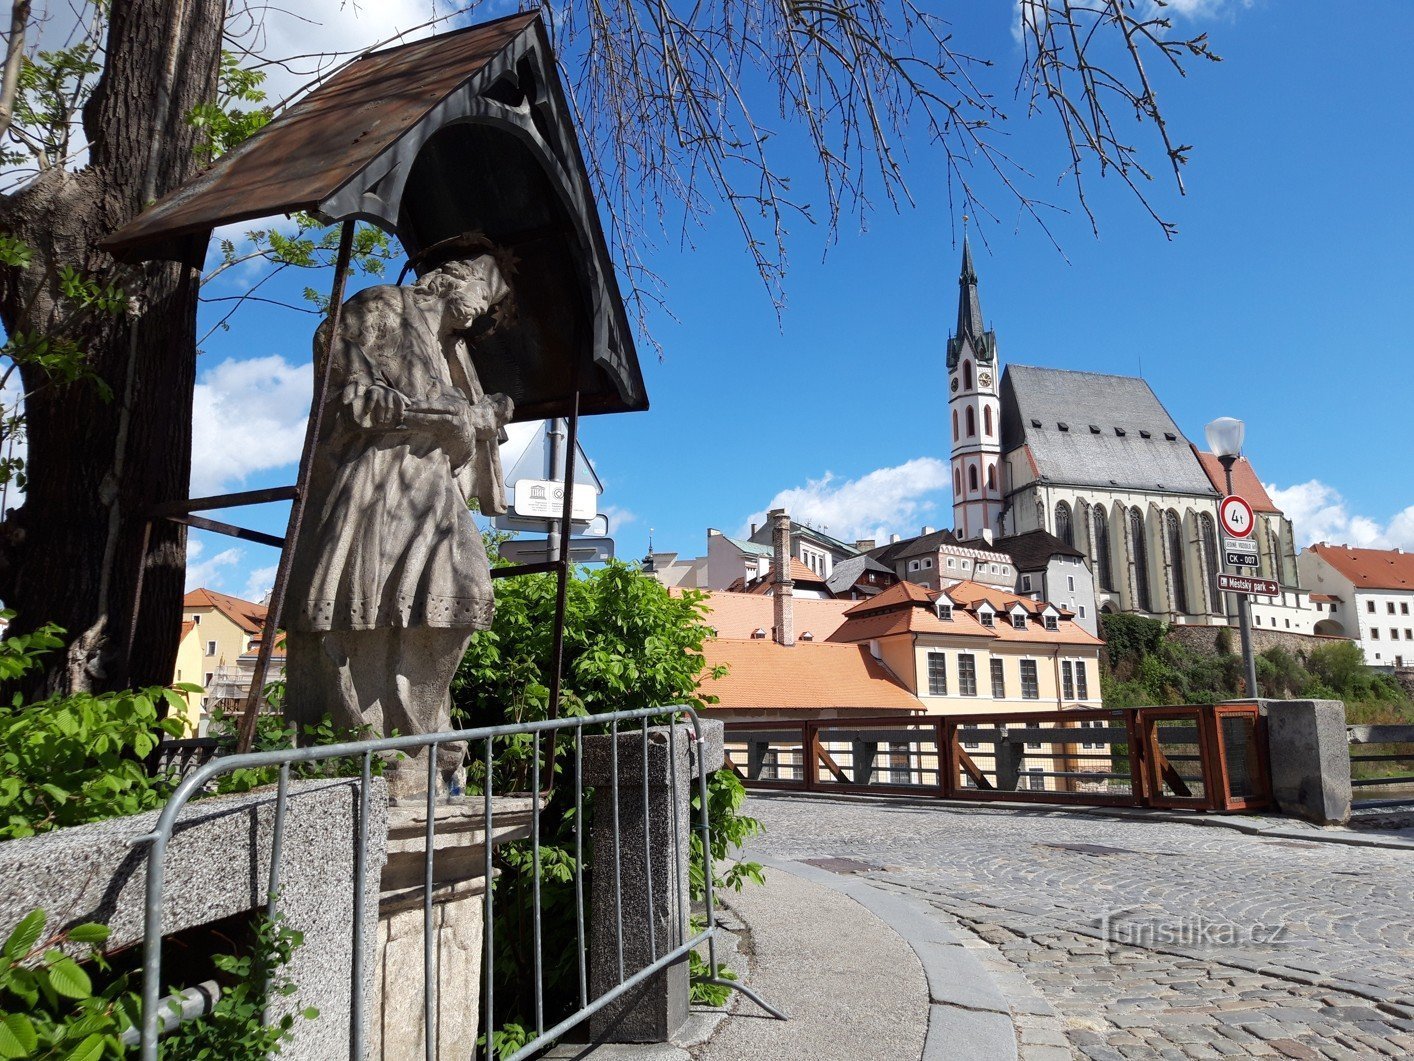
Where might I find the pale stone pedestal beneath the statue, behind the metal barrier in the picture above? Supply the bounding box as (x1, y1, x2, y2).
(369, 796, 534, 1061)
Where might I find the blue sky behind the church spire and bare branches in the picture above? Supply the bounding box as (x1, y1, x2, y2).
(182, 0, 1414, 594)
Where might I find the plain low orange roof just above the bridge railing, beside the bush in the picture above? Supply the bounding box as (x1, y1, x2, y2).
(701, 639, 925, 712)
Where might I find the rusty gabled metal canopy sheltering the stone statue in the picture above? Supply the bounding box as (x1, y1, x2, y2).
(103, 13, 648, 420)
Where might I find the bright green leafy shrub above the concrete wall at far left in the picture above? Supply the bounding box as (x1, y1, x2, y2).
(0, 613, 188, 840)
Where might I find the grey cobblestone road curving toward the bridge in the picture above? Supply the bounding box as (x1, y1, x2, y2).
(747, 795, 1414, 1061)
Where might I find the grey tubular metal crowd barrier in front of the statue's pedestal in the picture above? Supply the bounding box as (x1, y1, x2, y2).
(136, 706, 779, 1061)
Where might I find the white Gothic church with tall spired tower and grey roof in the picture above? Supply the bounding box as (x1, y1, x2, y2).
(947, 240, 1321, 634)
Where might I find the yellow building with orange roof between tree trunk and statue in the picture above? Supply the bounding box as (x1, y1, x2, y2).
(174, 589, 270, 733)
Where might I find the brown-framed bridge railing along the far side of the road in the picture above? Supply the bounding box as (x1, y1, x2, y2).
(725, 703, 1271, 811)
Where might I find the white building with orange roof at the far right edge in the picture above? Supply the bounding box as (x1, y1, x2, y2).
(1299, 542, 1414, 668)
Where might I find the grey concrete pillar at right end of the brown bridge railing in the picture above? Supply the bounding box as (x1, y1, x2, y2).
(1263, 700, 1350, 825)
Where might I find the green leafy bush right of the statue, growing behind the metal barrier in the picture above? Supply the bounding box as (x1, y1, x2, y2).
(452, 563, 761, 1041)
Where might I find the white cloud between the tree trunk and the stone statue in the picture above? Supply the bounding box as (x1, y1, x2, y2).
(191, 354, 311, 497)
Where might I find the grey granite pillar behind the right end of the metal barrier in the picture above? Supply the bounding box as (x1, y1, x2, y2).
(584, 720, 724, 1043)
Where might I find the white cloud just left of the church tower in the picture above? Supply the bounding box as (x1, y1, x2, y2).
(747, 457, 952, 540)
